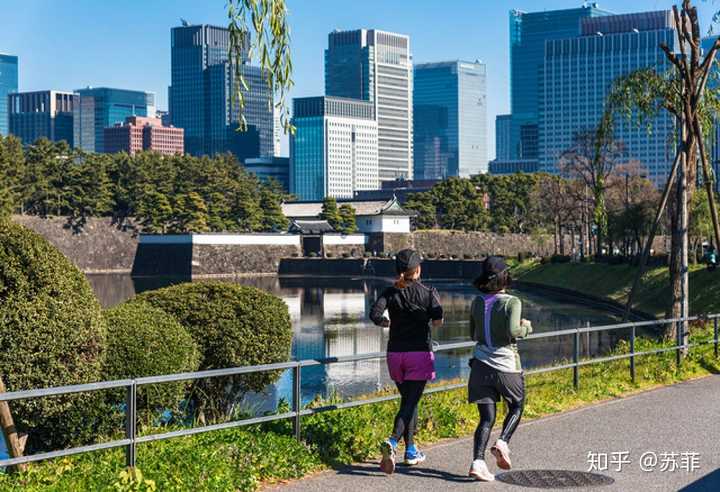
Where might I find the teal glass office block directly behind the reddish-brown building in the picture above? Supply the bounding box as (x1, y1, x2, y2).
(73, 87, 155, 152)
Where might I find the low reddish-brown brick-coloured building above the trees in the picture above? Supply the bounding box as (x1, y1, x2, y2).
(104, 116, 185, 155)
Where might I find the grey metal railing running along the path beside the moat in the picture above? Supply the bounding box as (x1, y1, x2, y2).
(0, 314, 720, 467)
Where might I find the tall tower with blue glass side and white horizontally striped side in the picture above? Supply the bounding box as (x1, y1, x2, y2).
(325, 29, 413, 181)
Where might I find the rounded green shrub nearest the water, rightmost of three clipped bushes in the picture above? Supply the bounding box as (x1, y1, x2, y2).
(131, 282, 292, 416)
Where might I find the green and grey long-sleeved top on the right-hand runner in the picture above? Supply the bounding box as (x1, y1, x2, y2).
(470, 293, 532, 372)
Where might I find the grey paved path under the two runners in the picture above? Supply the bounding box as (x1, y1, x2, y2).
(274, 376, 720, 492)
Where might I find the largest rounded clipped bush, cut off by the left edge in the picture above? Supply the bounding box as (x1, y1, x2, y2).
(0, 220, 105, 452)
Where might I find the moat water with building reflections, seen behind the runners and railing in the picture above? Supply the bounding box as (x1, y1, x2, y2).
(83, 275, 623, 411)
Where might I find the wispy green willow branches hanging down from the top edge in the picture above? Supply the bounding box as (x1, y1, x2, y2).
(227, 0, 295, 133)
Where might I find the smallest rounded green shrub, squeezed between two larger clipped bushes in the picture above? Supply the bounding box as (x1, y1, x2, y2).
(103, 302, 200, 413)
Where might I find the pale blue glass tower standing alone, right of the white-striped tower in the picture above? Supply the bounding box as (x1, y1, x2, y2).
(413, 60, 487, 179)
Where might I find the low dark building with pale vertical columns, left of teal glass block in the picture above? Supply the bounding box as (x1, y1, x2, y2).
(9, 91, 78, 147)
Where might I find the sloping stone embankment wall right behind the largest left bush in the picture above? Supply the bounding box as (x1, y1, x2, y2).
(13, 215, 138, 273)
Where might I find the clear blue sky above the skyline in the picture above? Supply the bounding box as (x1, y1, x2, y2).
(0, 0, 720, 157)
